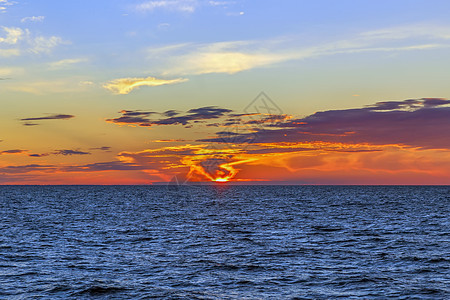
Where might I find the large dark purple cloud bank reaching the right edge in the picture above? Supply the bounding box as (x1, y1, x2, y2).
(199, 98, 450, 149)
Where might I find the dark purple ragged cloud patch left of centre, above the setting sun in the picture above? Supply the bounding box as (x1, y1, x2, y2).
(106, 106, 232, 127)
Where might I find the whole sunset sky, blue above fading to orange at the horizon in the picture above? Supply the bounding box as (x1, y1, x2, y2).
(0, 0, 450, 185)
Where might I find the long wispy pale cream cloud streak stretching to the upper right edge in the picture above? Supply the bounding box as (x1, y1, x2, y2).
(148, 25, 450, 76)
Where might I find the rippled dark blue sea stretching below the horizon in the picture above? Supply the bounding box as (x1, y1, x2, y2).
(0, 186, 450, 299)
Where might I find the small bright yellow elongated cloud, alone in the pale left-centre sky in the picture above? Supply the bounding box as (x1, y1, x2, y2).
(103, 77, 188, 95)
